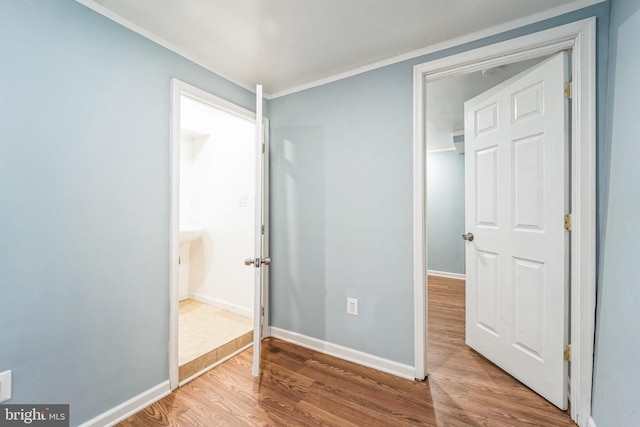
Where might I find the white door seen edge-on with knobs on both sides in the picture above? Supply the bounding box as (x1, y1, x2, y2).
(245, 85, 271, 377)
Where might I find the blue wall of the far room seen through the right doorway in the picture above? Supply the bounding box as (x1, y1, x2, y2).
(427, 150, 465, 274)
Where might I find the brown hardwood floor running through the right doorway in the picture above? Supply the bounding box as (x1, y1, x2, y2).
(119, 277, 575, 427)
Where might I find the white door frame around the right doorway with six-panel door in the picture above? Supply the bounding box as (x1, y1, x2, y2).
(413, 18, 596, 427)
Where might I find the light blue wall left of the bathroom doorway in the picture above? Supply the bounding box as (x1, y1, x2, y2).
(0, 0, 255, 425)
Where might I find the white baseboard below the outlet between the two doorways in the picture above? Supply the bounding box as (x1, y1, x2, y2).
(270, 326, 415, 380)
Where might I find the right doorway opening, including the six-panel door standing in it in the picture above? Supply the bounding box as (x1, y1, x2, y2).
(426, 52, 569, 422)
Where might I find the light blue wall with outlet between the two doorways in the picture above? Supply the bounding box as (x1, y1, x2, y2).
(269, 3, 609, 365)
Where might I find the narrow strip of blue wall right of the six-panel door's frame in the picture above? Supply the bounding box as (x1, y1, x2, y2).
(593, 0, 640, 427)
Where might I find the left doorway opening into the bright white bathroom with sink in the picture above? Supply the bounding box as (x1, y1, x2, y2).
(170, 80, 262, 389)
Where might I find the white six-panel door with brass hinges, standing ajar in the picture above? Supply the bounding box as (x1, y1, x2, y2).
(463, 52, 569, 409)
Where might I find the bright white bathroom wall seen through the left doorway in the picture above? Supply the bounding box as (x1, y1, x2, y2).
(180, 97, 255, 317)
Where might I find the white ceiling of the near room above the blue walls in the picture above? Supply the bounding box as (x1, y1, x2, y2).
(76, 0, 603, 97)
